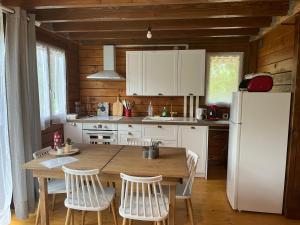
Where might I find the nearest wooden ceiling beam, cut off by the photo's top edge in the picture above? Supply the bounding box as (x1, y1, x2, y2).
(2, 0, 288, 9)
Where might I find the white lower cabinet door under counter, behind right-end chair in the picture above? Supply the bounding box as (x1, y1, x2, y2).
(178, 126, 208, 178)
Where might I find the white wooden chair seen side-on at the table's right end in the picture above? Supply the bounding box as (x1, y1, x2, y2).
(176, 150, 199, 225)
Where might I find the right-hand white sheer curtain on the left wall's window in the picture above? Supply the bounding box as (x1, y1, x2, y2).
(49, 48, 67, 123)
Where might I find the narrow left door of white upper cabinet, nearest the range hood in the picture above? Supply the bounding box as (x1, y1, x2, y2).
(126, 51, 143, 96)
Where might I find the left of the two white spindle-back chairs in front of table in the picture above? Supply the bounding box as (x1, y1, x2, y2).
(63, 166, 117, 225)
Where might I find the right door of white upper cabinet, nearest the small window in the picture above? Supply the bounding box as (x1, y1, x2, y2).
(178, 50, 205, 96)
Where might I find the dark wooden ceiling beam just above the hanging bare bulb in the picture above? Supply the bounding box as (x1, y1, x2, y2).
(52, 17, 272, 33)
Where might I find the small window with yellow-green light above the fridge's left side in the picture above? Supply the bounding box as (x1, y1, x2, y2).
(206, 52, 243, 105)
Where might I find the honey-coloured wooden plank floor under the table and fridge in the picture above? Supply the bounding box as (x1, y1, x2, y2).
(11, 168, 300, 225)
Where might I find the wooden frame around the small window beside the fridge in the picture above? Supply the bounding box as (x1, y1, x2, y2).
(205, 52, 245, 107)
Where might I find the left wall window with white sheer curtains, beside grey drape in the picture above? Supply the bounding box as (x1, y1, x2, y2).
(36, 43, 66, 130)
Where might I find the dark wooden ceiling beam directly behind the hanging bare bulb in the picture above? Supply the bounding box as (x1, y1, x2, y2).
(69, 28, 259, 40)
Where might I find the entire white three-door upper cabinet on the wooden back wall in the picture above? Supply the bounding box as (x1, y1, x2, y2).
(126, 50, 205, 96)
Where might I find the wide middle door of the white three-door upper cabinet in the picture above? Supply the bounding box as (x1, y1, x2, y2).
(143, 50, 178, 96)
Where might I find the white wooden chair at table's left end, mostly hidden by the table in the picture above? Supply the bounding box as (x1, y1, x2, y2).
(33, 146, 66, 225)
